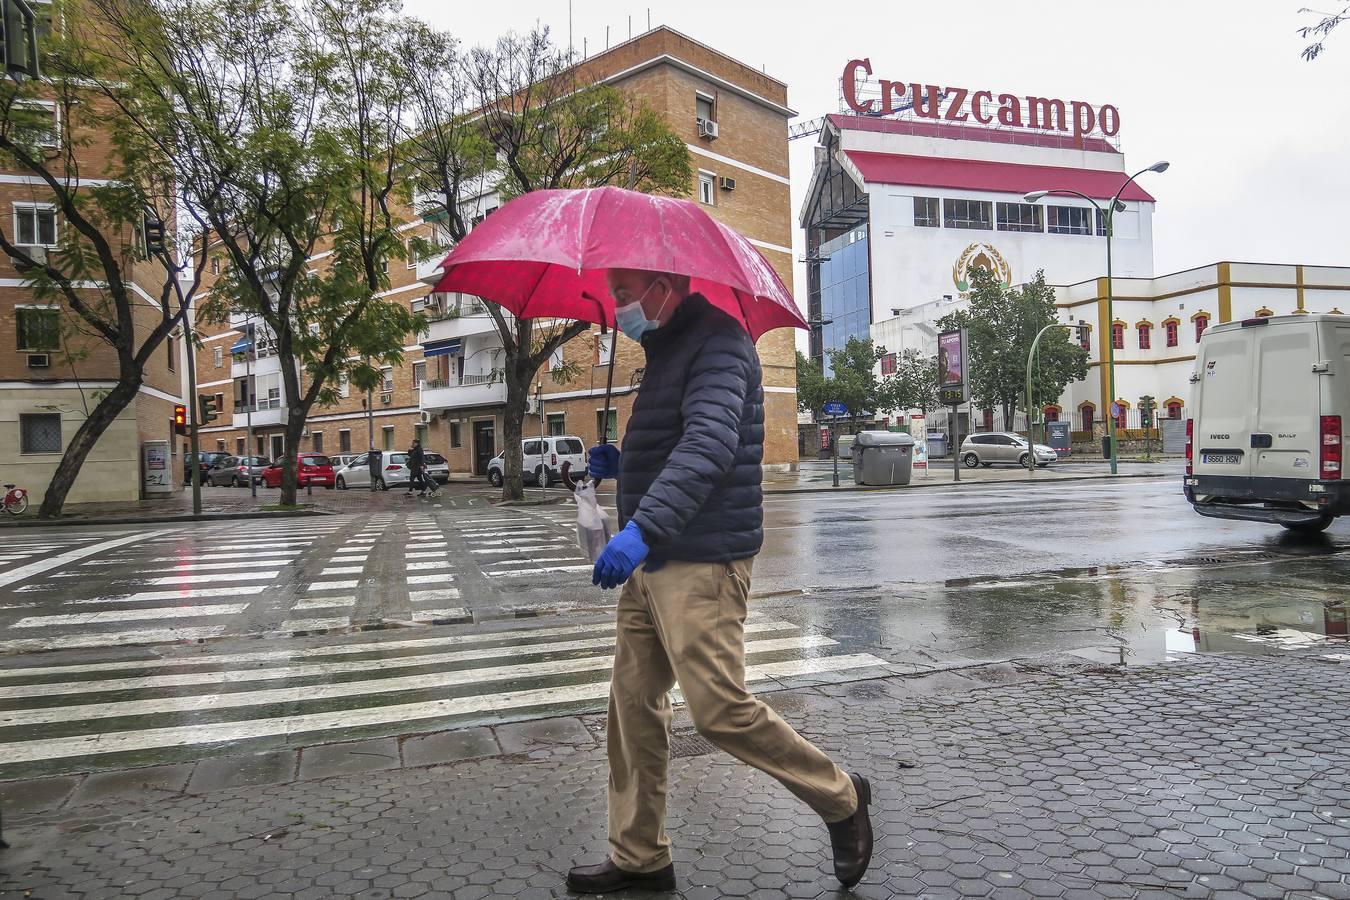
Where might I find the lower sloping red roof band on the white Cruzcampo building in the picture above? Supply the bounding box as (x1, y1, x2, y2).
(844, 150, 1157, 202)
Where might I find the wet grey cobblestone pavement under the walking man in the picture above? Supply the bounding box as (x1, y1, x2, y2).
(0, 648, 1350, 900)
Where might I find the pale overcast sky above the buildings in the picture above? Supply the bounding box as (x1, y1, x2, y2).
(406, 0, 1350, 287)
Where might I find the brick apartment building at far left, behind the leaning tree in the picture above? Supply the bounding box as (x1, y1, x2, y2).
(0, 105, 186, 503)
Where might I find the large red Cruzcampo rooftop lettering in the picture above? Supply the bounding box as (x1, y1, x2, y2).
(842, 58, 1121, 138)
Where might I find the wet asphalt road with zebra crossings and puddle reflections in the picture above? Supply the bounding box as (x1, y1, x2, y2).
(0, 476, 1350, 779)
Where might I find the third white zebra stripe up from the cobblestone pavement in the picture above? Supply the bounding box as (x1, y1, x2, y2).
(0, 620, 798, 679)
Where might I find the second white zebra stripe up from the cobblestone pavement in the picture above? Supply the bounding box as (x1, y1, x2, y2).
(0, 634, 838, 701)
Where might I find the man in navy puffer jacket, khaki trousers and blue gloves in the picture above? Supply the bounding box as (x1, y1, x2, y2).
(567, 270, 872, 893)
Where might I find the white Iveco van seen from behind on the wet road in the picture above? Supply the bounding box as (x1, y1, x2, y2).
(1185, 313, 1350, 532)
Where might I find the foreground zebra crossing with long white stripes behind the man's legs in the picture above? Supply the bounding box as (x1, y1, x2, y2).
(0, 607, 886, 779)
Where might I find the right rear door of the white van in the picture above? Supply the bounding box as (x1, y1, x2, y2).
(1243, 322, 1322, 479)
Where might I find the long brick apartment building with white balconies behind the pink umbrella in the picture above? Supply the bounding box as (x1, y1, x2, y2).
(191, 27, 797, 475)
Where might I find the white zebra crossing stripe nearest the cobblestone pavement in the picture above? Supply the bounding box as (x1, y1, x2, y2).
(0, 655, 886, 764)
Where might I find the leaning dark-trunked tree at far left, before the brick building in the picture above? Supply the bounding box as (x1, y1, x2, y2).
(0, 4, 201, 518)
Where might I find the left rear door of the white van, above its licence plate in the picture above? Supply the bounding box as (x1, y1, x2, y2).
(1193, 328, 1257, 476)
